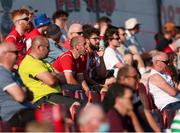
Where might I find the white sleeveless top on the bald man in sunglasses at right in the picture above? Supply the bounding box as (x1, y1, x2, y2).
(149, 69, 180, 110)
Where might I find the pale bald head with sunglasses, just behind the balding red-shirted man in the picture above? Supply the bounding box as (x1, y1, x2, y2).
(68, 23, 83, 39)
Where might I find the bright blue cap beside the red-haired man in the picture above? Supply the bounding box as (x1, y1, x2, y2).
(34, 13, 51, 28)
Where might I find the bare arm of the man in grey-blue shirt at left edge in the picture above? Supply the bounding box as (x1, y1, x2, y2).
(6, 84, 25, 102)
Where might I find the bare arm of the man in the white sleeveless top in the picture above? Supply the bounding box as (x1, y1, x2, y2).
(149, 74, 177, 96)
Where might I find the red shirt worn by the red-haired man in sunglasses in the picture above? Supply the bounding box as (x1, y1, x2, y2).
(5, 27, 26, 65)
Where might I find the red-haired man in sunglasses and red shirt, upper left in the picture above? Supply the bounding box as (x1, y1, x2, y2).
(5, 9, 29, 69)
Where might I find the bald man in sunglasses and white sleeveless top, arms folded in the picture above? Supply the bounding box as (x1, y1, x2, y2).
(148, 52, 180, 111)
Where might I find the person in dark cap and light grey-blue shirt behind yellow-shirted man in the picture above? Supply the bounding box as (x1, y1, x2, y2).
(44, 24, 66, 64)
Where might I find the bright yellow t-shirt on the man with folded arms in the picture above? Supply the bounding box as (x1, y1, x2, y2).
(18, 55, 61, 102)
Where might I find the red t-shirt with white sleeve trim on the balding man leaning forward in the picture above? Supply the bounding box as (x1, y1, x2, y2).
(52, 51, 84, 74)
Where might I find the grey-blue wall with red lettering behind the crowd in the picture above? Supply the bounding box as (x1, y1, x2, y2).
(0, 0, 180, 51)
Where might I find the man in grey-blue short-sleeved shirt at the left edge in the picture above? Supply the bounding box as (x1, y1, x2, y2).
(0, 43, 35, 127)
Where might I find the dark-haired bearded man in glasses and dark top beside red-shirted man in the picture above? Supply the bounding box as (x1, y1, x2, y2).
(84, 27, 113, 88)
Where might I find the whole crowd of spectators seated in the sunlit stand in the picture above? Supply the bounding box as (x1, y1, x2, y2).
(0, 7, 180, 132)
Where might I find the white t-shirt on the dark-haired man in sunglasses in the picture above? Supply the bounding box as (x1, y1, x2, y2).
(103, 47, 125, 77)
